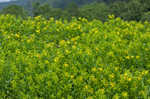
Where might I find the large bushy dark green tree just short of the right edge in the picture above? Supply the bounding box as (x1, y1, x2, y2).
(110, 0, 144, 21)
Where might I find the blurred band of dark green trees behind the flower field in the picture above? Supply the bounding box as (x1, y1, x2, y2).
(0, 0, 150, 21)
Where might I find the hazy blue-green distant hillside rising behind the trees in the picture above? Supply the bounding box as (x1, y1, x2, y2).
(0, 0, 128, 9)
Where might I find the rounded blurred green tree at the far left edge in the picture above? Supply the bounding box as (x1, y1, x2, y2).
(0, 5, 27, 18)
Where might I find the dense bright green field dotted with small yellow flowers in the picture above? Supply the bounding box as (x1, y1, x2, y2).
(0, 15, 150, 99)
